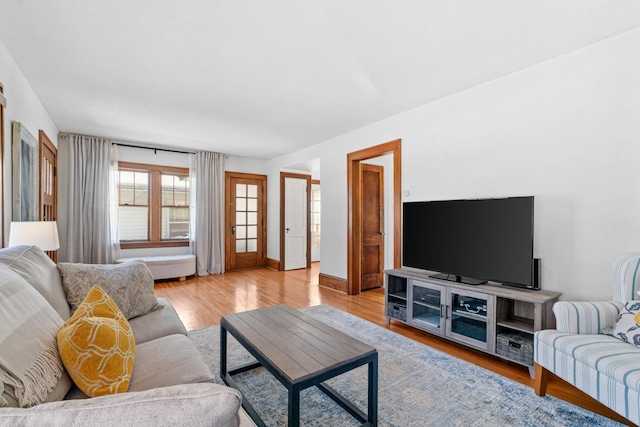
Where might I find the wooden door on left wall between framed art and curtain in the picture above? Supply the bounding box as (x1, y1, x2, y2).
(38, 131, 58, 263)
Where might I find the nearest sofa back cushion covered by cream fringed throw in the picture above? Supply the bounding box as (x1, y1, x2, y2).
(0, 265, 64, 407)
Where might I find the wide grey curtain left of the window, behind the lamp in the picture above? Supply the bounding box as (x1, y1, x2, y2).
(59, 134, 119, 264)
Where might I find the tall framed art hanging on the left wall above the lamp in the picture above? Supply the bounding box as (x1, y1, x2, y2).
(12, 122, 38, 221)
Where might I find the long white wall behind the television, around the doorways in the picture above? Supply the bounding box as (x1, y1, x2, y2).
(268, 30, 640, 300)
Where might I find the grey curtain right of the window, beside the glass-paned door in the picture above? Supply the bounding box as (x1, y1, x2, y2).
(189, 151, 225, 276)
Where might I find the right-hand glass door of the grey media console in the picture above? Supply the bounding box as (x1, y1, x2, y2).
(447, 289, 495, 351)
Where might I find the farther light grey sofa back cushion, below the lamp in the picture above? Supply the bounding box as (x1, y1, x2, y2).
(0, 246, 71, 320)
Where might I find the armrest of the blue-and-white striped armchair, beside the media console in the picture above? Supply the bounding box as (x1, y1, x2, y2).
(553, 301, 624, 334)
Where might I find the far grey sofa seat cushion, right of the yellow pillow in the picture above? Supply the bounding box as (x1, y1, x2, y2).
(129, 298, 187, 344)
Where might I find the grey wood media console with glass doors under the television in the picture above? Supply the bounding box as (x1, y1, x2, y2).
(385, 268, 561, 378)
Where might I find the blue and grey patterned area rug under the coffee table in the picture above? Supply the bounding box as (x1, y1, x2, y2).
(189, 305, 621, 427)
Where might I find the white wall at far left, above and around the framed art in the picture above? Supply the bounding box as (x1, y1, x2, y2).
(0, 41, 58, 243)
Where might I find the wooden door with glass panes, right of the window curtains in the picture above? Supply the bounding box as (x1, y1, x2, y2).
(225, 172, 267, 270)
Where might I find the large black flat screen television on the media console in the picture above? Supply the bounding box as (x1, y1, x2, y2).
(402, 196, 539, 289)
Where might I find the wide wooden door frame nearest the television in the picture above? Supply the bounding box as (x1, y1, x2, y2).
(347, 139, 402, 295)
